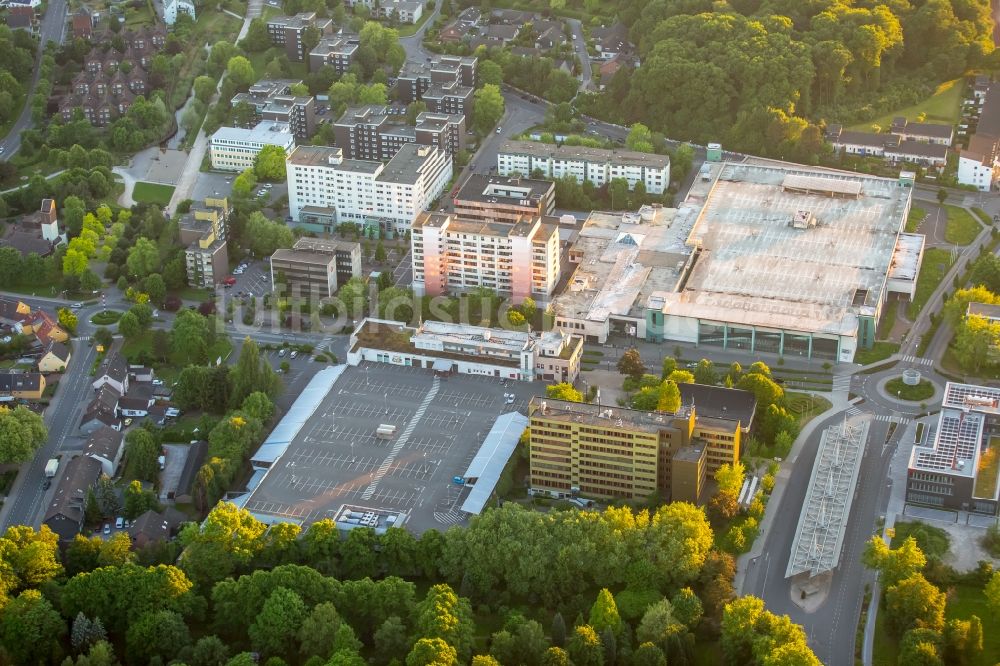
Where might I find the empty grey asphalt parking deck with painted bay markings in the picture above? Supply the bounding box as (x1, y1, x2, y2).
(246, 363, 543, 534)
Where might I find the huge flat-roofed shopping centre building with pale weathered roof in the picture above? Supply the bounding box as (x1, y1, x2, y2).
(554, 161, 923, 361)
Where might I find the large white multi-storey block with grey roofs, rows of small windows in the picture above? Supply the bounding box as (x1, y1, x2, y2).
(287, 143, 452, 233)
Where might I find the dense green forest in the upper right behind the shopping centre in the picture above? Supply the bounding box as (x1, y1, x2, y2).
(585, 0, 997, 160)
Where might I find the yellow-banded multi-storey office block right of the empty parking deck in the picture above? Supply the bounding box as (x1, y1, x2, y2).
(528, 398, 707, 502)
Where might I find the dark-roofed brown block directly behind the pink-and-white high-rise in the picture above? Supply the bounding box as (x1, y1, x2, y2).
(454, 173, 556, 222)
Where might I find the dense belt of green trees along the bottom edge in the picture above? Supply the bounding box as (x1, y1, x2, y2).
(0, 503, 819, 666)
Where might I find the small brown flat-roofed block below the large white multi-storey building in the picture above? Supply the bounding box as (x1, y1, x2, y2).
(271, 233, 361, 298)
